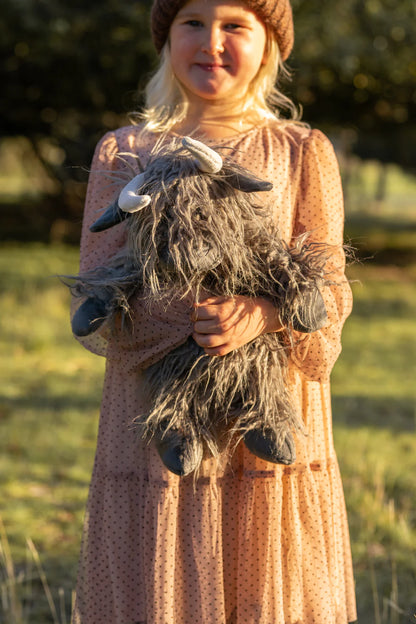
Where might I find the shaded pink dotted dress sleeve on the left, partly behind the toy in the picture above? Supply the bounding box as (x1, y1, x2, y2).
(71, 132, 192, 370)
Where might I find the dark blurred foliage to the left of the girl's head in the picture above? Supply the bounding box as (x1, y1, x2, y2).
(0, 0, 154, 210)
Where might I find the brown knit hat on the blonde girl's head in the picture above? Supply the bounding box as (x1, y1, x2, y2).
(151, 0, 294, 61)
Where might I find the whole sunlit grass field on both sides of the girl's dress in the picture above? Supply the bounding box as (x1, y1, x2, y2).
(0, 238, 416, 624)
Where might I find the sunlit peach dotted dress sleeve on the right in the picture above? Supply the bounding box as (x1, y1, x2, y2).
(292, 130, 352, 381)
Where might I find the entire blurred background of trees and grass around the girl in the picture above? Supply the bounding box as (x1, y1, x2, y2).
(0, 0, 416, 624)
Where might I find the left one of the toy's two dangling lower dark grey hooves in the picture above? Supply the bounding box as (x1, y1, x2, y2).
(155, 431, 203, 477)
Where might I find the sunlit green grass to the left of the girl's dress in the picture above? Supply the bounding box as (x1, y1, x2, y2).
(0, 245, 104, 624)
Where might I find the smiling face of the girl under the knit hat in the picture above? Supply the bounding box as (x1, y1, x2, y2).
(170, 0, 266, 111)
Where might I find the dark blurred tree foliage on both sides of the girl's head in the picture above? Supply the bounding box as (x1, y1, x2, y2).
(0, 0, 416, 177)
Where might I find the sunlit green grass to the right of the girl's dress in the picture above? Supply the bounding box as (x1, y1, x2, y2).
(332, 262, 416, 624)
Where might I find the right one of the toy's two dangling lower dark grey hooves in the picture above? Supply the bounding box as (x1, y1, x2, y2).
(244, 429, 296, 465)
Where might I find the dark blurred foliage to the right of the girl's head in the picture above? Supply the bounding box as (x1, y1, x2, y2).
(293, 0, 416, 167)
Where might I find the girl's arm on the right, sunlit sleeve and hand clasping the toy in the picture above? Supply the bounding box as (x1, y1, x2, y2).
(191, 131, 352, 381)
